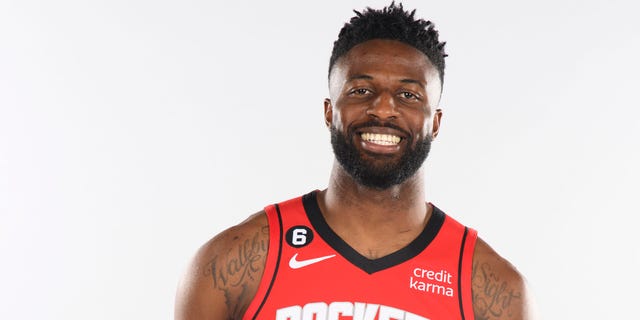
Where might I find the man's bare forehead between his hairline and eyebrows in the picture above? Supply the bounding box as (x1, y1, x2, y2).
(331, 39, 439, 82)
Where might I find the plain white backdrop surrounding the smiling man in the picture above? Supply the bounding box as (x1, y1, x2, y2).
(0, 0, 640, 319)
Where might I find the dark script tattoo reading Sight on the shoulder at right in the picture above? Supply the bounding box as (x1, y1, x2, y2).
(471, 263, 521, 320)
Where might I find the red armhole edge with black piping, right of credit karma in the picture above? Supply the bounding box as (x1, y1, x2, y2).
(459, 228, 478, 320)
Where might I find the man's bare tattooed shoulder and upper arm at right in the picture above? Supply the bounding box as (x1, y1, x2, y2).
(471, 239, 535, 320)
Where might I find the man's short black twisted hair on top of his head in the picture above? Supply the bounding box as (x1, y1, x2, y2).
(329, 1, 447, 83)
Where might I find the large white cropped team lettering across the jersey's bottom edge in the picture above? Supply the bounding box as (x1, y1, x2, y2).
(276, 301, 429, 320)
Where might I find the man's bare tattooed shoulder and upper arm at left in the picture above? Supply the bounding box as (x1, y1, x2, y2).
(175, 211, 269, 320)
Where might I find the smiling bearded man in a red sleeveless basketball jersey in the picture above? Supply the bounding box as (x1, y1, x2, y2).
(175, 3, 531, 320)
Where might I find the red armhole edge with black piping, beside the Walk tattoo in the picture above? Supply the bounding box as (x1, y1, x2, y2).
(242, 204, 283, 320)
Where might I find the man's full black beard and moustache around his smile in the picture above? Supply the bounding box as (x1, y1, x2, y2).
(330, 122, 431, 190)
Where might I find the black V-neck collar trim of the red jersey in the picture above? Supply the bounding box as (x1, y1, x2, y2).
(302, 191, 445, 274)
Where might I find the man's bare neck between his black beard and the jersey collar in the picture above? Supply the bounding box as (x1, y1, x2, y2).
(318, 163, 432, 259)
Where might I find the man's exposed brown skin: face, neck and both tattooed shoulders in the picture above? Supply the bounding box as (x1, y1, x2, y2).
(175, 40, 533, 320)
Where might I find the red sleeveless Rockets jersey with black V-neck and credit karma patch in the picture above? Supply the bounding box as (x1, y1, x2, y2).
(243, 191, 477, 320)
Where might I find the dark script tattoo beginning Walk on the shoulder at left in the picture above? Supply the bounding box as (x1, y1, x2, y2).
(202, 226, 269, 319)
